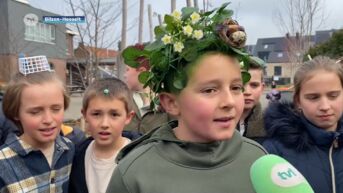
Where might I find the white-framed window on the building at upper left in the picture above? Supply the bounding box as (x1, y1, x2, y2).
(25, 23, 56, 44)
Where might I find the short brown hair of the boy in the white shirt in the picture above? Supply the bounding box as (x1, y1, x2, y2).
(82, 78, 132, 113)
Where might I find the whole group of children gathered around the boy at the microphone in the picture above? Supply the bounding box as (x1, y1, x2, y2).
(0, 1, 343, 193)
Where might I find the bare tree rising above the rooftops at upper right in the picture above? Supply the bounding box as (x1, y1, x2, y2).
(274, 0, 325, 82)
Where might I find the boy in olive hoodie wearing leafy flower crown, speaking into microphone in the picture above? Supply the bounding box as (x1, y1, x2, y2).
(107, 4, 266, 193)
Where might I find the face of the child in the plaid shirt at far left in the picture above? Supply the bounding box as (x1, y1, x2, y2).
(17, 82, 64, 149)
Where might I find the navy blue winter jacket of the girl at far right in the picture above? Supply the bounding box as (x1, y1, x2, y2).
(263, 102, 343, 193)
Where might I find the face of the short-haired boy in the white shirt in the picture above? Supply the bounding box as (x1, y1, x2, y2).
(82, 97, 132, 147)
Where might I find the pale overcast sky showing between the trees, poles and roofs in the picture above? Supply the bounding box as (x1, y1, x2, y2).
(28, 0, 343, 44)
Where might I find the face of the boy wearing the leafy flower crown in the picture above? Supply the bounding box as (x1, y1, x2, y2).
(170, 55, 244, 142)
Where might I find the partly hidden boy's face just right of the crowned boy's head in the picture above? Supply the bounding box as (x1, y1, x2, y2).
(244, 69, 264, 111)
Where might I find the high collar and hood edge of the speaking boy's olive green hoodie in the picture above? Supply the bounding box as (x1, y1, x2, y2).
(117, 121, 243, 168)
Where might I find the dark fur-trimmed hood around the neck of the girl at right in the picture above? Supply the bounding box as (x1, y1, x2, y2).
(264, 101, 343, 151)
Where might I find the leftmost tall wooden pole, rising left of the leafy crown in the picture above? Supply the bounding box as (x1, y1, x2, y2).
(117, 0, 127, 80)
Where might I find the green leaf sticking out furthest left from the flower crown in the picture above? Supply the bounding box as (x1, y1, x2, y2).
(122, 47, 149, 68)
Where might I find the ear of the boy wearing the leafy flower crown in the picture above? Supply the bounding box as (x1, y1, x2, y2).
(159, 93, 180, 116)
